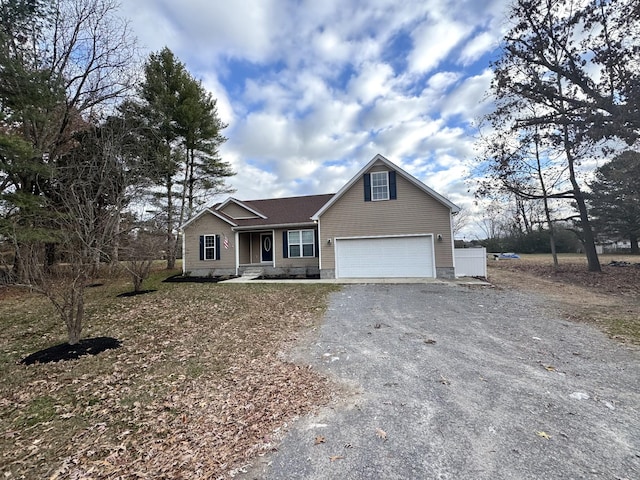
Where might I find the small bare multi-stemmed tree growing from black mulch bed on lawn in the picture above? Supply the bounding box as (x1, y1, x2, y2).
(16, 125, 129, 345)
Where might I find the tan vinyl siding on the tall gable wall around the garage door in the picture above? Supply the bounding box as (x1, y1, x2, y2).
(319, 164, 453, 269)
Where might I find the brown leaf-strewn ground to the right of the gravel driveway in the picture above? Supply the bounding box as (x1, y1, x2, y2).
(488, 255, 640, 345)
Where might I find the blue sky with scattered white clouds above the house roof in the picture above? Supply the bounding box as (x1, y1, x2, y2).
(121, 0, 508, 238)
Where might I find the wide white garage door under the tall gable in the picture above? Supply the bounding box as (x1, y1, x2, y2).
(336, 235, 435, 278)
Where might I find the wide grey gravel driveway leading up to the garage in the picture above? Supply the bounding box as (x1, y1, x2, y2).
(250, 284, 640, 480)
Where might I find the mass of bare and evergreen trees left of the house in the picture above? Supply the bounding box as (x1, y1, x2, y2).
(0, 0, 234, 344)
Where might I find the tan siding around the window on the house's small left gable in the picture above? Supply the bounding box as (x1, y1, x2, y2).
(183, 213, 236, 272)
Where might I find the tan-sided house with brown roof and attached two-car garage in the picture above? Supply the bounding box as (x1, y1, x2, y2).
(182, 155, 459, 278)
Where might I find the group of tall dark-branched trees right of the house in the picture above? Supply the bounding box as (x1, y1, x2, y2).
(477, 0, 640, 271)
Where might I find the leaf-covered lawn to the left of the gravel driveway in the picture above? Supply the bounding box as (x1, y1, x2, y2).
(0, 271, 334, 479)
